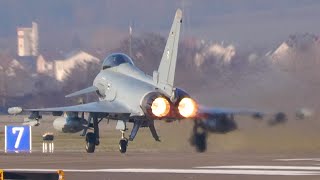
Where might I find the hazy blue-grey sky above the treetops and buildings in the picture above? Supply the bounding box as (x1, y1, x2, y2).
(0, 0, 320, 46)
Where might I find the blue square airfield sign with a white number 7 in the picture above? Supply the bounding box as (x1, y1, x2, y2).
(5, 126, 32, 153)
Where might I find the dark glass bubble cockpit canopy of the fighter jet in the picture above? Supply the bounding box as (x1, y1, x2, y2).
(102, 53, 134, 69)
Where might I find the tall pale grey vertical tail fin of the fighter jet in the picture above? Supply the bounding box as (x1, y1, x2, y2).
(154, 9, 182, 95)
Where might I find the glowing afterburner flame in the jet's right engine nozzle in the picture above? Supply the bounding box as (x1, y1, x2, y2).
(178, 97, 198, 118)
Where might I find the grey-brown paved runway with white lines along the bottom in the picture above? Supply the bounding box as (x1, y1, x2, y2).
(0, 152, 320, 180)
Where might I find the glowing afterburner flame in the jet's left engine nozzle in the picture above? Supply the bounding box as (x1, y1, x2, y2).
(151, 97, 170, 117)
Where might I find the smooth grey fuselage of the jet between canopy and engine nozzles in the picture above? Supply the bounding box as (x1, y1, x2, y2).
(93, 60, 170, 119)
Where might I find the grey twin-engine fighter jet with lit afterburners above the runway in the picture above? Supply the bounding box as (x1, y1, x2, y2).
(9, 9, 284, 153)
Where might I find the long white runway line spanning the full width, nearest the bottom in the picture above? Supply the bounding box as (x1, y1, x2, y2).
(4, 168, 320, 176)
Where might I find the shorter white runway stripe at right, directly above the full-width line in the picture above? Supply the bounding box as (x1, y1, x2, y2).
(194, 165, 320, 172)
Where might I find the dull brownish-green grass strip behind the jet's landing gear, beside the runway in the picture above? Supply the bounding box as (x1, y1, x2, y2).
(0, 116, 320, 154)
